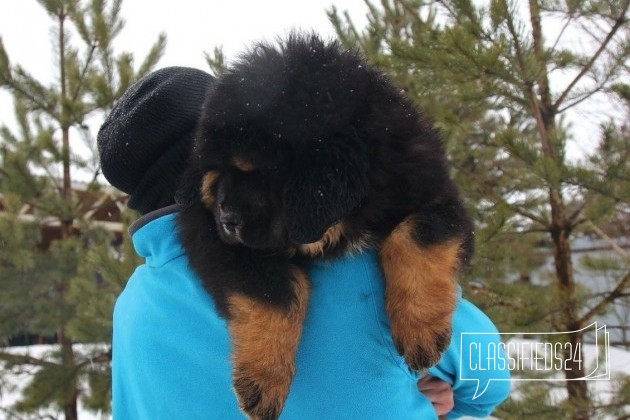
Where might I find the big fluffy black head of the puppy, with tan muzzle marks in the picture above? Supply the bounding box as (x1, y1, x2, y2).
(178, 35, 386, 249)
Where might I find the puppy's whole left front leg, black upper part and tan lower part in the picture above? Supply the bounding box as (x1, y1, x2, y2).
(179, 203, 309, 420)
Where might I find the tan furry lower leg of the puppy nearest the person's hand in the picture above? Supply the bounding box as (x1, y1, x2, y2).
(379, 218, 461, 370)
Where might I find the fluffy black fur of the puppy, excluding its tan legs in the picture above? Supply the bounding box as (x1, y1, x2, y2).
(178, 34, 473, 418)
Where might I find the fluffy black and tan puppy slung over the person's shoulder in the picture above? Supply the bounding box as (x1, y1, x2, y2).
(179, 34, 472, 419)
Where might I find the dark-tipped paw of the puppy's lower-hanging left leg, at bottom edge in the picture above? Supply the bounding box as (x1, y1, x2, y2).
(234, 374, 292, 420)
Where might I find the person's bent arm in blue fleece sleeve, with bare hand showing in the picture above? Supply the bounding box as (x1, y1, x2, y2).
(430, 299, 510, 419)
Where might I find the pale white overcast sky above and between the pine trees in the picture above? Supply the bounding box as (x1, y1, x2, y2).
(0, 0, 624, 164)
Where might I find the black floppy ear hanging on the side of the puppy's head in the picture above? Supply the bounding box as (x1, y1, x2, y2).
(283, 143, 368, 244)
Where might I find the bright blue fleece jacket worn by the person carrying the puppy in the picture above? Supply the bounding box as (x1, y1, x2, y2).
(112, 214, 509, 420)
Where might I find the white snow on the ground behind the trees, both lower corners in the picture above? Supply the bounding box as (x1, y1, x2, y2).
(0, 338, 630, 420)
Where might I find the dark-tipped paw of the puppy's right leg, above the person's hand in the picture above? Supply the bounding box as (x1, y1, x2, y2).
(392, 320, 451, 371)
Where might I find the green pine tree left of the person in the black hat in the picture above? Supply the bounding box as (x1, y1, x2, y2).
(0, 0, 166, 420)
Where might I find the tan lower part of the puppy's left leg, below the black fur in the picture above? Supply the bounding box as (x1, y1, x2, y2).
(228, 268, 308, 420)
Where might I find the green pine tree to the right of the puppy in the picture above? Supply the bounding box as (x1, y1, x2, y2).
(329, 0, 630, 418)
